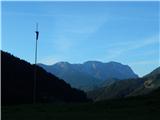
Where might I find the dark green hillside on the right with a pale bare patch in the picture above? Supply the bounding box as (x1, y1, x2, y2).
(87, 68, 160, 101)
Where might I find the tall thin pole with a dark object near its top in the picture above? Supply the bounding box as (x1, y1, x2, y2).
(33, 23, 39, 103)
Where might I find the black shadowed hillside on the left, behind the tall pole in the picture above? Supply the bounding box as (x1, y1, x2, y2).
(1, 51, 87, 105)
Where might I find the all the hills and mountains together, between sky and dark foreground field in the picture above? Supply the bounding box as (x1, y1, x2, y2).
(1, 51, 160, 105)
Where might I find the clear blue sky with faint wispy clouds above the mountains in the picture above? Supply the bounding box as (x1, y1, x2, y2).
(1, 1, 160, 76)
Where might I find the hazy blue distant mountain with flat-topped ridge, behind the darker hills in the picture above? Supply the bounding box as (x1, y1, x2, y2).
(39, 61, 138, 91)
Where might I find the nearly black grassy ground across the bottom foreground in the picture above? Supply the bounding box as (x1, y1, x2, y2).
(2, 92, 160, 120)
